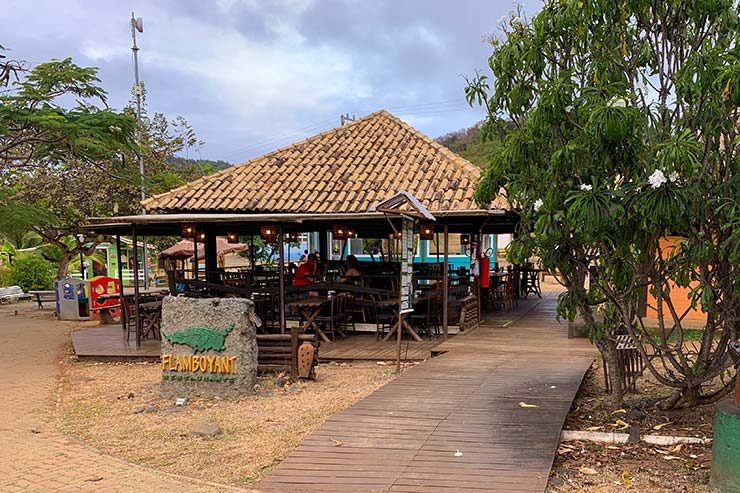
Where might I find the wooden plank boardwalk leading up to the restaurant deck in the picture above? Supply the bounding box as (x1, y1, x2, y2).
(258, 295, 595, 493)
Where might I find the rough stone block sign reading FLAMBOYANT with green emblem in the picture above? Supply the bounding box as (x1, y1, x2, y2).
(161, 296, 257, 396)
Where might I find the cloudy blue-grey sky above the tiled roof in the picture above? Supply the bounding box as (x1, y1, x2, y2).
(0, 0, 539, 163)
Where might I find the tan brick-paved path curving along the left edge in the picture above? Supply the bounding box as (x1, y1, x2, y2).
(0, 305, 246, 493)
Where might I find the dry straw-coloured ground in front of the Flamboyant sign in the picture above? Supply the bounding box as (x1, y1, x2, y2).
(55, 356, 394, 486)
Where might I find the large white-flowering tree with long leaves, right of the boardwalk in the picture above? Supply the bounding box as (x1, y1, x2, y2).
(466, 0, 740, 407)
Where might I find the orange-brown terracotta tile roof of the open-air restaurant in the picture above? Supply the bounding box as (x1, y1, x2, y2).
(143, 111, 508, 213)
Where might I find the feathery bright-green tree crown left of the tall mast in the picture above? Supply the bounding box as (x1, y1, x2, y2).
(0, 47, 136, 172)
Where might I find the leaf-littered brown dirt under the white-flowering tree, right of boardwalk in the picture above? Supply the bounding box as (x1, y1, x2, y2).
(547, 360, 714, 493)
